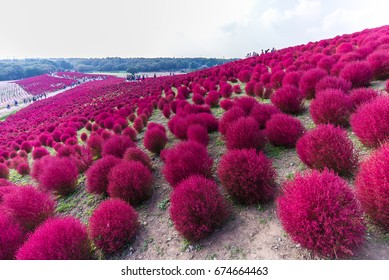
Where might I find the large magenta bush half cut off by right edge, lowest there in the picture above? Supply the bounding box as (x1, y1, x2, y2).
(356, 144, 389, 230)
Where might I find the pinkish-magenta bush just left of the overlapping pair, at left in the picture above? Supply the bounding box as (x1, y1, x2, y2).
(37, 156, 78, 195)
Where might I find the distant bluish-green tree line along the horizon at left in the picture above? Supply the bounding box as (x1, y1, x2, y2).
(0, 57, 234, 81)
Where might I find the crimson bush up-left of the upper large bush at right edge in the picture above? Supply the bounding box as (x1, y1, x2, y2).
(309, 89, 353, 126)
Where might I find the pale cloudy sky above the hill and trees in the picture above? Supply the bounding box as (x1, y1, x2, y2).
(0, 0, 389, 58)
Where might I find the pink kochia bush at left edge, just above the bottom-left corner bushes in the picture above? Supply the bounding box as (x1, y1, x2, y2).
(2, 186, 55, 231)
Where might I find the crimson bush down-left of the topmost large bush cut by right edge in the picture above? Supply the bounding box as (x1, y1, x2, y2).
(339, 61, 373, 88)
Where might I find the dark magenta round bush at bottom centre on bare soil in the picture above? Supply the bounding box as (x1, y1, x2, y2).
(170, 175, 229, 241)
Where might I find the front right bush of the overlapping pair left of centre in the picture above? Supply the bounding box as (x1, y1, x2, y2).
(107, 161, 153, 205)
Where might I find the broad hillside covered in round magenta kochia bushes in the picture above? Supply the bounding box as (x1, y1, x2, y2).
(0, 26, 389, 259)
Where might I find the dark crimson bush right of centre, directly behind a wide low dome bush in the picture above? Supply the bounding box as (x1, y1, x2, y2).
(270, 85, 304, 114)
